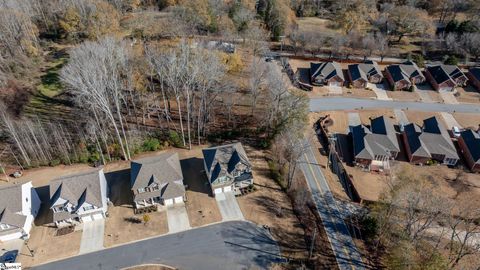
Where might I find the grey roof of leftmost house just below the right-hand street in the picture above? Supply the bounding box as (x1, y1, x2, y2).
(352, 116, 400, 159)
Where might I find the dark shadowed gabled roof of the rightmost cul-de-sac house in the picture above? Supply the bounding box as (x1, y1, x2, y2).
(202, 143, 250, 183)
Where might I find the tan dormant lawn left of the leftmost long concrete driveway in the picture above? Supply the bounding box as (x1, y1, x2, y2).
(18, 226, 82, 268)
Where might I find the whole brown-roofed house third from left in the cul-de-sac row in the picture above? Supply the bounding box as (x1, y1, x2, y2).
(130, 153, 185, 209)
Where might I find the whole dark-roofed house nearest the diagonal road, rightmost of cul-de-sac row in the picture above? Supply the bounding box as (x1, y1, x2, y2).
(202, 143, 253, 195)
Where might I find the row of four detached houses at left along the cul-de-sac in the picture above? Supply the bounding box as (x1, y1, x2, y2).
(0, 143, 253, 241)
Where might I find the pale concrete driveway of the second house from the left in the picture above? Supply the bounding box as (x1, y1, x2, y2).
(80, 219, 105, 254)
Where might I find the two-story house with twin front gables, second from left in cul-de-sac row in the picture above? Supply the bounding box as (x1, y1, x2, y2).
(50, 169, 108, 227)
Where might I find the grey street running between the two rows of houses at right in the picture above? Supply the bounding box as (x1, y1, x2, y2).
(310, 97, 480, 113)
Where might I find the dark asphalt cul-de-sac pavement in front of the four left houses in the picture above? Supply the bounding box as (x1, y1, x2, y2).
(32, 221, 281, 270)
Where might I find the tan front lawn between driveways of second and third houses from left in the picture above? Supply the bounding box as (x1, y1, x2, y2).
(104, 206, 168, 247)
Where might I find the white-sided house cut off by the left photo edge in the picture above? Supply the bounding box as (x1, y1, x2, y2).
(0, 182, 41, 242)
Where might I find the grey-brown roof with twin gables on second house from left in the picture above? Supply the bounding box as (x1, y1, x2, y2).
(50, 169, 103, 207)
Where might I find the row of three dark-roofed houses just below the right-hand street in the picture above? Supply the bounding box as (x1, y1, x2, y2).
(350, 116, 480, 172)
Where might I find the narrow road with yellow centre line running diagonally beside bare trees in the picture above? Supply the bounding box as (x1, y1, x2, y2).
(300, 140, 365, 270)
